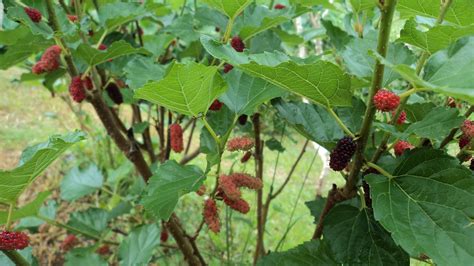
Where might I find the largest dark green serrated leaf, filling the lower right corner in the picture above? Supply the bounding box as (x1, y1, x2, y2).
(365, 149, 474, 265)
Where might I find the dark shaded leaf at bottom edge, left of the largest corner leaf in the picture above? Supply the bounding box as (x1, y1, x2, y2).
(323, 205, 410, 265)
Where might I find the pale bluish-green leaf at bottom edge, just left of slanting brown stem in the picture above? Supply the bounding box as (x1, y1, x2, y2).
(119, 224, 160, 266)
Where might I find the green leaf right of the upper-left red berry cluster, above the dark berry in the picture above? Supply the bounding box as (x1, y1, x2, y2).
(76, 40, 150, 66)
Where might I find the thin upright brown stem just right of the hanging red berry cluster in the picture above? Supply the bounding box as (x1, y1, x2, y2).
(252, 113, 265, 264)
